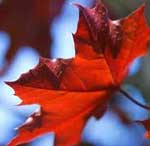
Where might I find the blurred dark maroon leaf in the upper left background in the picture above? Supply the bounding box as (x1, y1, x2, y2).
(0, 0, 64, 72)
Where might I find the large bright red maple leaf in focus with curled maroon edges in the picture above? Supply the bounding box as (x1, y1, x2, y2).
(7, 3, 149, 146)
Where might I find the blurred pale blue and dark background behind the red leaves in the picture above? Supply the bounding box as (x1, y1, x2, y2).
(0, 0, 150, 146)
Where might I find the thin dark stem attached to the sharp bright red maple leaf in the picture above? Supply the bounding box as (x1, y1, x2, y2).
(119, 88, 150, 110)
